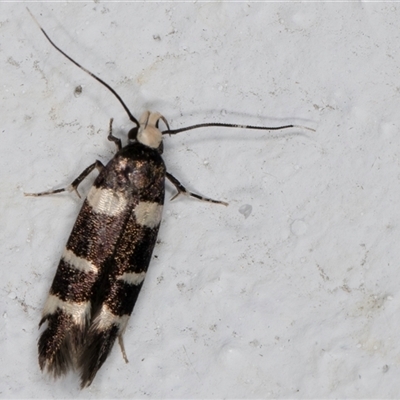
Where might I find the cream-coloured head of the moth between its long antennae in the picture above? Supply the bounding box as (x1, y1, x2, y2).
(128, 111, 169, 153)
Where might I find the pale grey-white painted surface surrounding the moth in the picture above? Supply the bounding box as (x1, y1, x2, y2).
(0, 2, 400, 398)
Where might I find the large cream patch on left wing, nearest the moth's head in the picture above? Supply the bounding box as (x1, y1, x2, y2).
(86, 186, 128, 217)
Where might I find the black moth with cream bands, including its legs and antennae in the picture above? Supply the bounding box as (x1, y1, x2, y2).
(26, 10, 312, 388)
